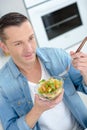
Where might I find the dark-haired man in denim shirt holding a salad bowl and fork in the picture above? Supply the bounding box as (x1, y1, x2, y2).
(0, 13, 87, 130)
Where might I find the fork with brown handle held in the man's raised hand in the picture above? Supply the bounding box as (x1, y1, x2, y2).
(59, 37, 87, 77)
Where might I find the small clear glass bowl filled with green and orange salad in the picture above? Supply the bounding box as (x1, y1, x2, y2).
(36, 76, 63, 100)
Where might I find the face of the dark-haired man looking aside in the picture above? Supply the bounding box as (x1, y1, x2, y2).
(4, 21, 36, 67)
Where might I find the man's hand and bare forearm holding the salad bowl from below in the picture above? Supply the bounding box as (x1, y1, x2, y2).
(25, 90, 64, 128)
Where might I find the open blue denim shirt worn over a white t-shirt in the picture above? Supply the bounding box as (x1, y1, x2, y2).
(0, 48, 87, 130)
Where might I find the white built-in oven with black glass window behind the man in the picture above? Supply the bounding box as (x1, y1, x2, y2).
(27, 0, 87, 49)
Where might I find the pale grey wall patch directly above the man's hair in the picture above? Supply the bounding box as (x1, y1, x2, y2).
(0, 0, 27, 17)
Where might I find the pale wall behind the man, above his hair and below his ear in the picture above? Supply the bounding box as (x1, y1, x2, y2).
(0, 0, 28, 68)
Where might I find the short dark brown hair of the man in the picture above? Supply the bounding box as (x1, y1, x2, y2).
(0, 12, 28, 42)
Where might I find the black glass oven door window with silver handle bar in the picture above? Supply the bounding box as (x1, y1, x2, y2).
(42, 2, 82, 40)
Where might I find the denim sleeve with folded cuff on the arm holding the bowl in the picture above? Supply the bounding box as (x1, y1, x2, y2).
(0, 89, 32, 130)
